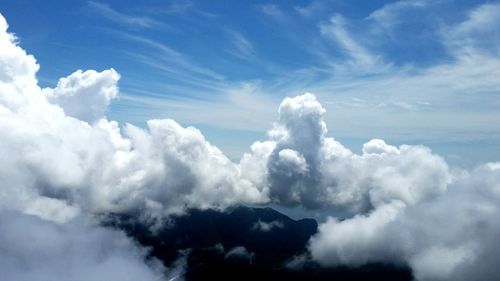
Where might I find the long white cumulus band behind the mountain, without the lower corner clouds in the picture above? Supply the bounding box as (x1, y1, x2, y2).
(0, 10, 450, 225)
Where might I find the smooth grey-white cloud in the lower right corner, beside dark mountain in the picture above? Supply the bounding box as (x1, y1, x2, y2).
(309, 163, 500, 280)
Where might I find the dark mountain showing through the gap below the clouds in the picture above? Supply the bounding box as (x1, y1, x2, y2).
(105, 207, 413, 281)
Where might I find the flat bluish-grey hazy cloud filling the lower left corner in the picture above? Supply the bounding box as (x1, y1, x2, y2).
(0, 212, 164, 281)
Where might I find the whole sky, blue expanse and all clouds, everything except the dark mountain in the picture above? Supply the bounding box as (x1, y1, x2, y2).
(0, 1, 500, 281)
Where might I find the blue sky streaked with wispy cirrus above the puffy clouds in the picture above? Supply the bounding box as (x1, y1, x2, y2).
(0, 0, 500, 166)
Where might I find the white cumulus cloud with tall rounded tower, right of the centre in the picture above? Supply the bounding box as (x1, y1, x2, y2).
(248, 94, 452, 214)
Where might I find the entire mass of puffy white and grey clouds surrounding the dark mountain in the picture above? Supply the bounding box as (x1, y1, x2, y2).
(0, 12, 500, 280)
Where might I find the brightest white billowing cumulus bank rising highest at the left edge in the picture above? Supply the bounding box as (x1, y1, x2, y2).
(0, 10, 265, 220)
